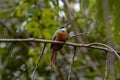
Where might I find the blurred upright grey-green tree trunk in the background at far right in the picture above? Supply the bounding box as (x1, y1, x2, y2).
(102, 0, 115, 80)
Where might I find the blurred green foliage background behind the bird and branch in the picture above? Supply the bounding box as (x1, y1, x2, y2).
(0, 0, 120, 80)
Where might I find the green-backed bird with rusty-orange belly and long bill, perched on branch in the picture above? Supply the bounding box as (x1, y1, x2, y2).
(50, 21, 71, 67)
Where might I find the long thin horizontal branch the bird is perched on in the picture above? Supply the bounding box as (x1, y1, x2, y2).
(0, 38, 120, 53)
